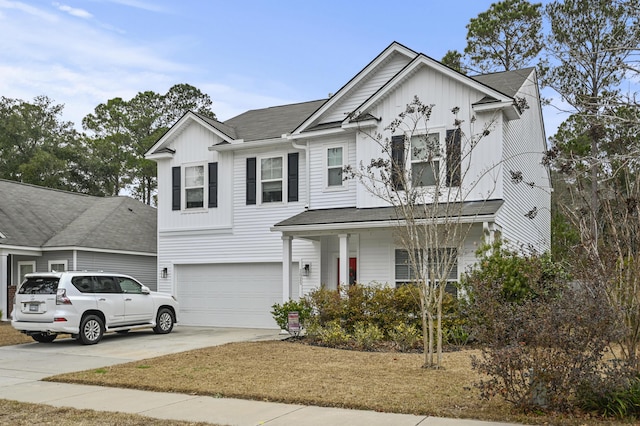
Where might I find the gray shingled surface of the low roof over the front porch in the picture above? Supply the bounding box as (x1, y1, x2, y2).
(275, 200, 503, 227)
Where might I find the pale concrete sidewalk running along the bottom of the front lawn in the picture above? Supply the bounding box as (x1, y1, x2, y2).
(0, 381, 507, 426)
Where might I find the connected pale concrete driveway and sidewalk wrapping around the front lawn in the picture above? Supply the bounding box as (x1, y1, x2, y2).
(0, 327, 520, 426)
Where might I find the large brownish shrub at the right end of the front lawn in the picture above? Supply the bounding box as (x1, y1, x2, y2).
(466, 243, 619, 410)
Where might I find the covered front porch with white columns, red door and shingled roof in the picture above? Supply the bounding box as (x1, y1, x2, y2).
(272, 200, 502, 302)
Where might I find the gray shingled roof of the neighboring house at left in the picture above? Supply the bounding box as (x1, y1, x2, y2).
(0, 179, 157, 253)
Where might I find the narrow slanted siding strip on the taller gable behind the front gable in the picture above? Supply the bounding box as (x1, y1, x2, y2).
(319, 53, 411, 123)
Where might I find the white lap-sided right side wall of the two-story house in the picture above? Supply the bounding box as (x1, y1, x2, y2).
(496, 73, 551, 252)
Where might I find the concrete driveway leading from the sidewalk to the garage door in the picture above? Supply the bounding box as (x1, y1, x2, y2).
(0, 325, 279, 387)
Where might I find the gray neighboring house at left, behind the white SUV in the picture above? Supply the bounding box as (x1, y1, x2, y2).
(0, 179, 157, 320)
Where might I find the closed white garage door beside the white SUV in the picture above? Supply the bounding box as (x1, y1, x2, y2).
(175, 263, 282, 328)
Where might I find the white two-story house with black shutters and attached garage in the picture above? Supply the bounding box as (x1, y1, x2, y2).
(146, 43, 550, 327)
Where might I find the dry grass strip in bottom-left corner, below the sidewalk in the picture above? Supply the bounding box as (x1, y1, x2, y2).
(0, 399, 218, 426)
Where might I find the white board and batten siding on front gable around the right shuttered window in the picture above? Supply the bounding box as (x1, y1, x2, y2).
(356, 66, 502, 207)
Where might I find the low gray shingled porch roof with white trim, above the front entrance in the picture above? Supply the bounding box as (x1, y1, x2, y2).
(273, 200, 504, 232)
